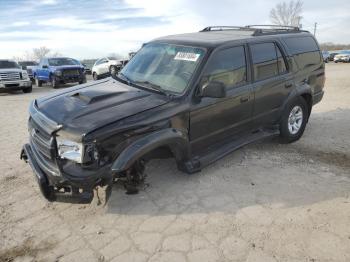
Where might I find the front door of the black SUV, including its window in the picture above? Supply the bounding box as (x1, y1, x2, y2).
(190, 45, 253, 153)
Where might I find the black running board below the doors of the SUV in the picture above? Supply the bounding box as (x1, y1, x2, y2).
(185, 129, 279, 174)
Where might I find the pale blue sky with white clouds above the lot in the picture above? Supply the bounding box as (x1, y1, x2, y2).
(0, 0, 350, 59)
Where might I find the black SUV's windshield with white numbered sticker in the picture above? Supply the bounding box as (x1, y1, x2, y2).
(120, 43, 205, 94)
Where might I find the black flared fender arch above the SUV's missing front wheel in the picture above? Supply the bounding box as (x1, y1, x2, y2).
(112, 128, 190, 172)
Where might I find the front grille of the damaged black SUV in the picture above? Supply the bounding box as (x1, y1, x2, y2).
(28, 118, 58, 174)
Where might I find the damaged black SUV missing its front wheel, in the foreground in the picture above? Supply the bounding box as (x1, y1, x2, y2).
(21, 27, 325, 203)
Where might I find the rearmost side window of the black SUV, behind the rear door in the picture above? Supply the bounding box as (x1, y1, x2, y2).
(284, 36, 321, 69)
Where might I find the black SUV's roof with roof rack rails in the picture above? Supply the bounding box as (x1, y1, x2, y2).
(153, 26, 309, 47)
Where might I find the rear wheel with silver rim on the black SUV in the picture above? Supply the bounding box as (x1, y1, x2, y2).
(280, 97, 309, 143)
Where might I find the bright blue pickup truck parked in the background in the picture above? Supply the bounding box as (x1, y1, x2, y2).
(34, 57, 86, 88)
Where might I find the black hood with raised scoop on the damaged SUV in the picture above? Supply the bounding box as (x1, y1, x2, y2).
(37, 78, 169, 134)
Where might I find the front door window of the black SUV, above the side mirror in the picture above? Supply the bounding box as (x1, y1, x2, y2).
(202, 46, 247, 88)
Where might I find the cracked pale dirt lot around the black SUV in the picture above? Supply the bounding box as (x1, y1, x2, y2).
(0, 64, 350, 262)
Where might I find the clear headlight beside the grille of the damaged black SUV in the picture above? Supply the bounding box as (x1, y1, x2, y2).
(56, 137, 83, 163)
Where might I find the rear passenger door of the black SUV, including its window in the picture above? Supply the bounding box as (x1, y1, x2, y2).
(249, 41, 294, 127)
